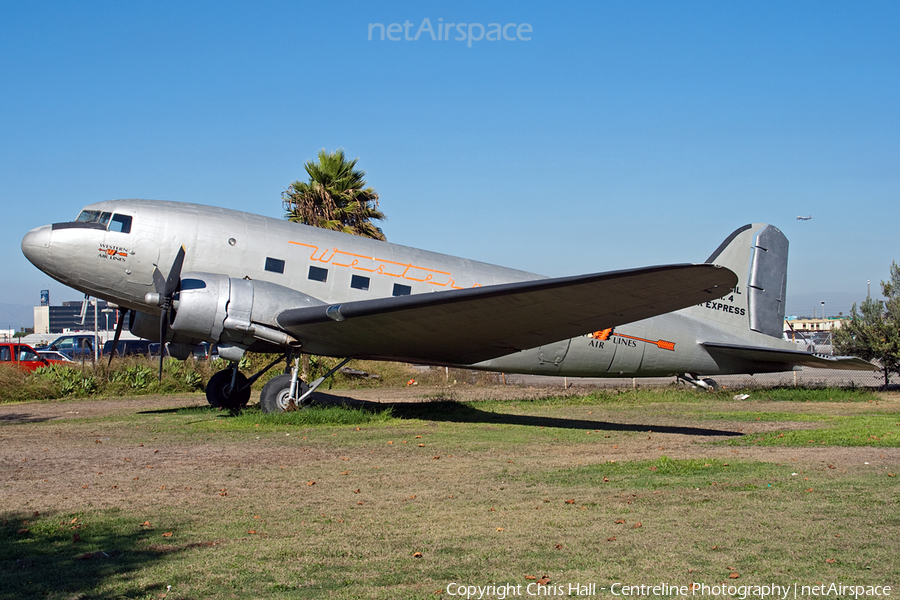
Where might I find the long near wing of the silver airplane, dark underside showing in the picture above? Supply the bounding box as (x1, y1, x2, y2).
(277, 264, 737, 365)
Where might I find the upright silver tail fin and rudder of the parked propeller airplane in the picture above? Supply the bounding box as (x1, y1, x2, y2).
(685, 223, 788, 338)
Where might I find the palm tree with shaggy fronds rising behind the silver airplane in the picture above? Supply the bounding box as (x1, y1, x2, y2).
(281, 150, 387, 240)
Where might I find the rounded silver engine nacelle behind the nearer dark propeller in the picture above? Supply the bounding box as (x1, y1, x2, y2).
(171, 272, 325, 358)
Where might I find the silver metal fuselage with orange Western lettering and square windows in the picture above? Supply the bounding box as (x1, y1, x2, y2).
(22, 200, 796, 377)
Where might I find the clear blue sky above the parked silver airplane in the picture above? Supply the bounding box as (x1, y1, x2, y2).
(0, 1, 900, 327)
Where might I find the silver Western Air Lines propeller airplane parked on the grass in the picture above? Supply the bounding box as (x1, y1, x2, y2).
(22, 200, 876, 412)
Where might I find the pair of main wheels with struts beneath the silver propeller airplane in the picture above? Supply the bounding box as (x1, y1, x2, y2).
(206, 350, 350, 413)
